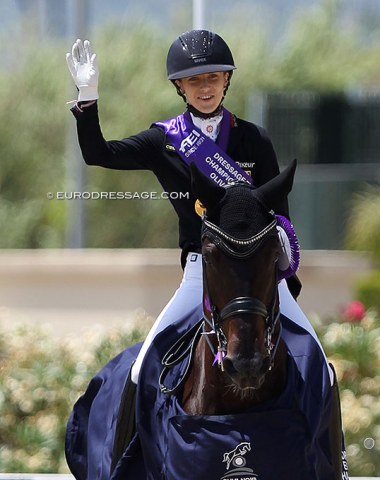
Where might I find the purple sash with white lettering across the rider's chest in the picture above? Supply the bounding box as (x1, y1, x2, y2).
(155, 107, 252, 187)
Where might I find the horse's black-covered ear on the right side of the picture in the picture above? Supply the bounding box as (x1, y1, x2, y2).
(255, 160, 297, 211)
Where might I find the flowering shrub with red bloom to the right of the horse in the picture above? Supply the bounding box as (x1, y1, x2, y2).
(317, 301, 380, 476)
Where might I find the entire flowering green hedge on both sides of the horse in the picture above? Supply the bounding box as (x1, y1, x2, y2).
(0, 308, 380, 476)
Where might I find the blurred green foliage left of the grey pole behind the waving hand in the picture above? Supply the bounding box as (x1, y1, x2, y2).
(0, 32, 66, 248)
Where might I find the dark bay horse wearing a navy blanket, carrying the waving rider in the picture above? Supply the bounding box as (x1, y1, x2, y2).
(66, 159, 348, 480)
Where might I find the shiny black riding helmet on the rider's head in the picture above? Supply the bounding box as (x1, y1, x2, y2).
(166, 30, 236, 80)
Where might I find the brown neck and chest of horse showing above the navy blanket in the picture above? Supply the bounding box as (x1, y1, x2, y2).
(182, 339, 287, 415)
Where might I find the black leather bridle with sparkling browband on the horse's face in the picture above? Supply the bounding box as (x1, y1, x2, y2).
(202, 217, 282, 373)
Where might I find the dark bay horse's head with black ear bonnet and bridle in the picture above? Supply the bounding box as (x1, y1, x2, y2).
(192, 161, 296, 389)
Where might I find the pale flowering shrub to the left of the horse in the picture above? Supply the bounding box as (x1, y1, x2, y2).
(0, 314, 151, 473)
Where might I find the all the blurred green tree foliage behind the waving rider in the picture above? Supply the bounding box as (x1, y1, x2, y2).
(0, 0, 380, 248)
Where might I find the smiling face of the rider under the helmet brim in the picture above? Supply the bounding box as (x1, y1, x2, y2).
(176, 72, 229, 113)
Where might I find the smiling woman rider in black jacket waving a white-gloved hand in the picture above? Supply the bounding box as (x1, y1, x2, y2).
(66, 30, 324, 383)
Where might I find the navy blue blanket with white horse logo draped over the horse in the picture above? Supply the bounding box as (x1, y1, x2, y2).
(66, 309, 348, 480)
